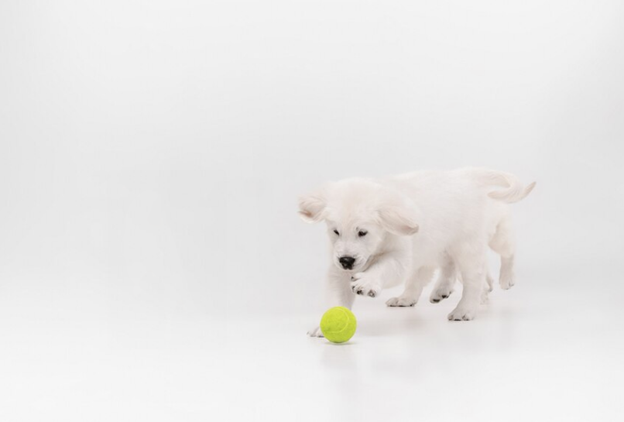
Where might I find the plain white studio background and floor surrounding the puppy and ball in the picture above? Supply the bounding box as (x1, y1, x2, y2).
(0, 0, 624, 421)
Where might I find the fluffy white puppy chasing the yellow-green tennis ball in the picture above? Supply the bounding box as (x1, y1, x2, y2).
(299, 168, 535, 337)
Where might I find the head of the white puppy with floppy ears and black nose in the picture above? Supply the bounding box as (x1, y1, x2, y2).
(299, 179, 418, 272)
